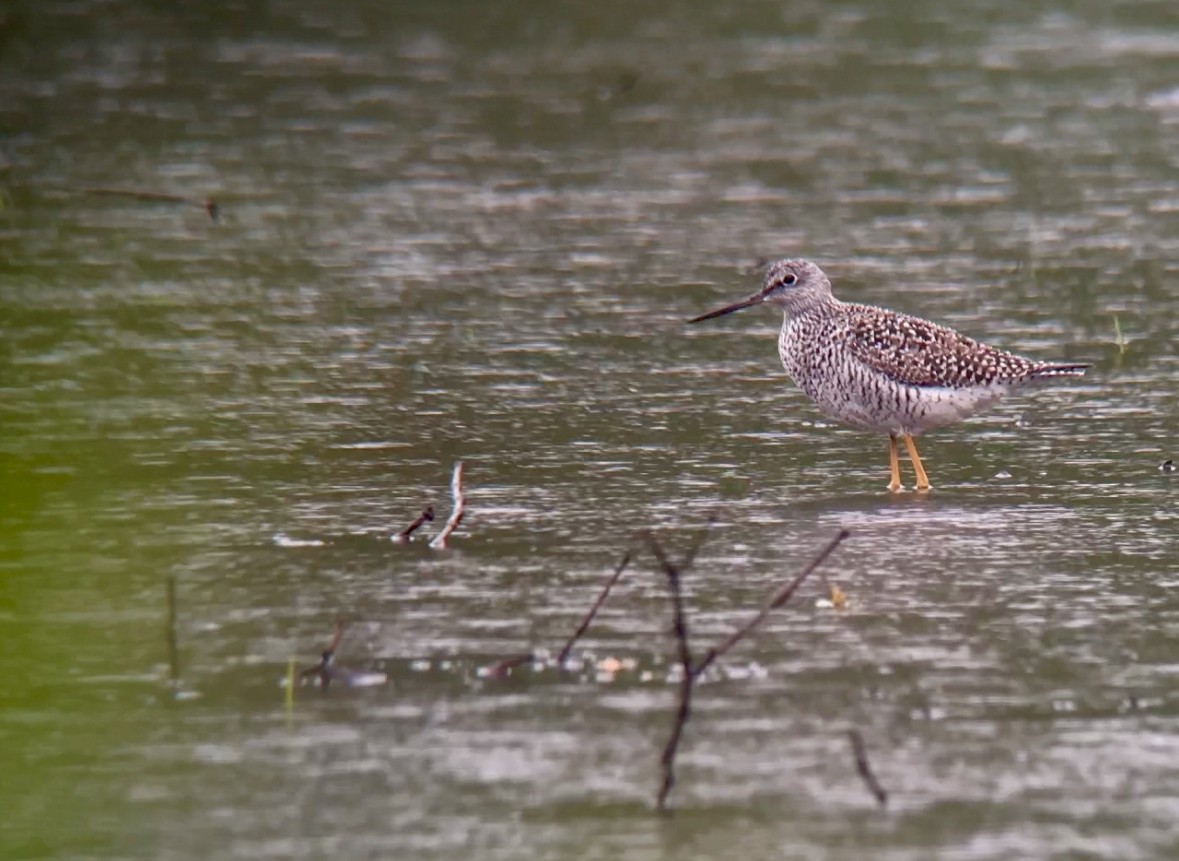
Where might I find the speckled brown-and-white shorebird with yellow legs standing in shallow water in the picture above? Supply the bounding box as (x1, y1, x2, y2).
(687, 259, 1089, 493)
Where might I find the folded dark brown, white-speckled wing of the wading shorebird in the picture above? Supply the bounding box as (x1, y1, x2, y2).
(847, 305, 1036, 388)
